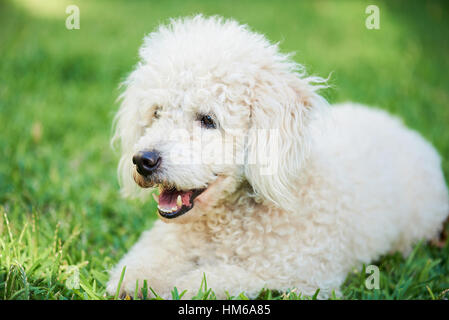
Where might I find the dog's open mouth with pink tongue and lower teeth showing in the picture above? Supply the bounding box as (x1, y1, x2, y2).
(153, 188, 206, 219)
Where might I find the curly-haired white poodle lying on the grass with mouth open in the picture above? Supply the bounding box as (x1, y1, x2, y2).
(107, 16, 449, 298)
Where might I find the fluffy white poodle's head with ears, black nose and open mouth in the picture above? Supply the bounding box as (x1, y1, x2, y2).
(114, 16, 325, 221)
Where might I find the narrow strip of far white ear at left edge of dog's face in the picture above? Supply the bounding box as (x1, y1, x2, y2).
(111, 74, 144, 197)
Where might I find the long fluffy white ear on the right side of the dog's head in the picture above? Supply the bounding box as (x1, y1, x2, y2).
(245, 72, 327, 211)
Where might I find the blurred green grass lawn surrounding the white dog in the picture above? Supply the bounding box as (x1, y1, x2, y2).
(0, 0, 449, 299)
